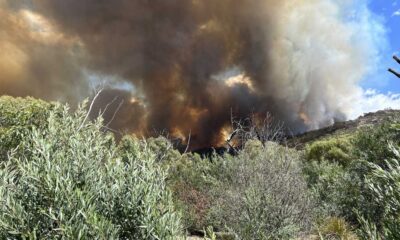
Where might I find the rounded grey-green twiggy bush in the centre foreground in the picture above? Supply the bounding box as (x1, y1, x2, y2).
(214, 141, 312, 239)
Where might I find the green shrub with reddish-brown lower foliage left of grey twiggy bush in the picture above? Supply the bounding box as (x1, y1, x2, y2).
(119, 131, 223, 232)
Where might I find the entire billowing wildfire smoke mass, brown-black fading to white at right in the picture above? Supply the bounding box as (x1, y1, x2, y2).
(0, 0, 384, 146)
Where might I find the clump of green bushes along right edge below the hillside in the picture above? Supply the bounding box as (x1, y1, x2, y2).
(304, 122, 400, 239)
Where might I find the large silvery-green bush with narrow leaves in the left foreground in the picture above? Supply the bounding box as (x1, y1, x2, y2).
(0, 101, 181, 239)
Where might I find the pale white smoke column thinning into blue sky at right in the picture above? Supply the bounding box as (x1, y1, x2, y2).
(268, 0, 392, 128)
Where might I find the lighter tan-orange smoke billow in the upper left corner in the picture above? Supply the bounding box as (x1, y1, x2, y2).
(0, 1, 87, 103)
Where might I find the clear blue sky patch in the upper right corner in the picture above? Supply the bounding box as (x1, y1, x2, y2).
(362, 0, 400, 93)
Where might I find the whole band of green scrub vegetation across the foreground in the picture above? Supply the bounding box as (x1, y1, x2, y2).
(0, 97, 400, 240)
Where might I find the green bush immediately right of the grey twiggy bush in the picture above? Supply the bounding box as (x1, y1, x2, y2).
(304, 155, 383, 228)
